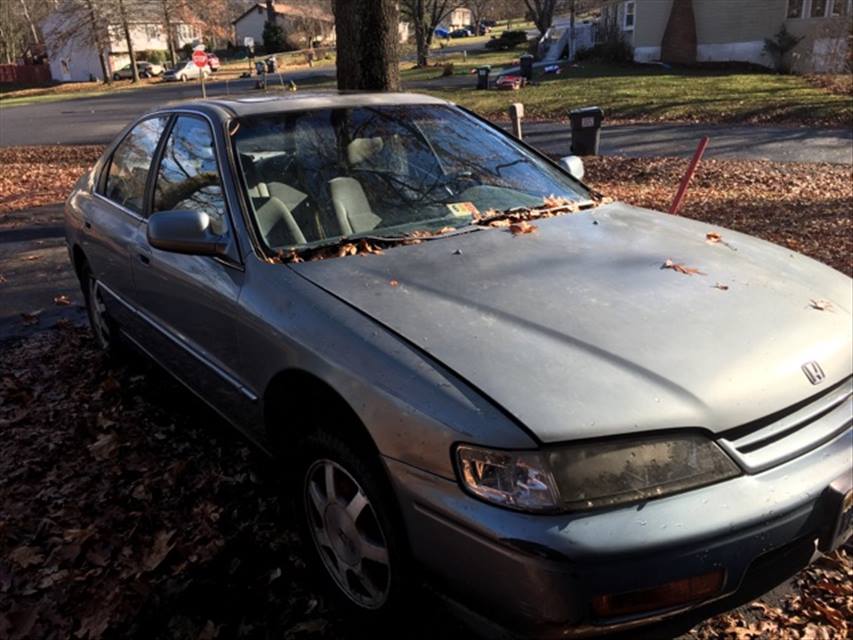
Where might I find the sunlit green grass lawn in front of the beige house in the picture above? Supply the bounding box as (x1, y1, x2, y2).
(427, 62, 853, 126)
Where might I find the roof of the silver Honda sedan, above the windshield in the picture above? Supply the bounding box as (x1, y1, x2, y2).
(178, 91, 451, 117)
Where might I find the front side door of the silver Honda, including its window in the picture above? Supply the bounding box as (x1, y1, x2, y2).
(126, 114, 254, 424)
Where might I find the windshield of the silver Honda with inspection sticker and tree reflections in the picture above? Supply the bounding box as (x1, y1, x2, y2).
(234, 105, 589, 250)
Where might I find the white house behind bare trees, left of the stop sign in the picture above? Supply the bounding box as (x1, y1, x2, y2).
(41, 10, 201, 82)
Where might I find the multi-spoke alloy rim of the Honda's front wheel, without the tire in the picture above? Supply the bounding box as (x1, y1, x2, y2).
(305, 459, 391, 609)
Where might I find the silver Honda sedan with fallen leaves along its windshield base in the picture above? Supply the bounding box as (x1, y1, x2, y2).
(66, 94, 853, 637)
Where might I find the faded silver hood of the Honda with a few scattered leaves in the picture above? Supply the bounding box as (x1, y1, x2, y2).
(293, 203, 853, 442)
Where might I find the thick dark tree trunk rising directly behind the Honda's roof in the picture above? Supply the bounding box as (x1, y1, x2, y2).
(333, 0, 400, 91)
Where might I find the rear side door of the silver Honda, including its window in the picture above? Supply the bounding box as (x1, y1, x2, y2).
(80, 116, 168, 325)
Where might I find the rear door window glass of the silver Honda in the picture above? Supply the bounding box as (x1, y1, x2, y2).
(104, 116, 167, 215)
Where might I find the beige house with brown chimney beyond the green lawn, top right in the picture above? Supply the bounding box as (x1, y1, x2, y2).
(599, 0, 853, 72)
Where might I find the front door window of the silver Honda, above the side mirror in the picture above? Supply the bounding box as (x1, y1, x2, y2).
(151, 116, 228, 235)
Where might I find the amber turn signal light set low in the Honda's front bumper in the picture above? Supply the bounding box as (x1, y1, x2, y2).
(592, 569, 725, 618)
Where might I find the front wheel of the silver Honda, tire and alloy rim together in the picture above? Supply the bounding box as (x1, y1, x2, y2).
(298, 432, 408, 621)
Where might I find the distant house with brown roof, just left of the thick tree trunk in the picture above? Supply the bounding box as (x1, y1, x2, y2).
(232, 2, 335, 49)
